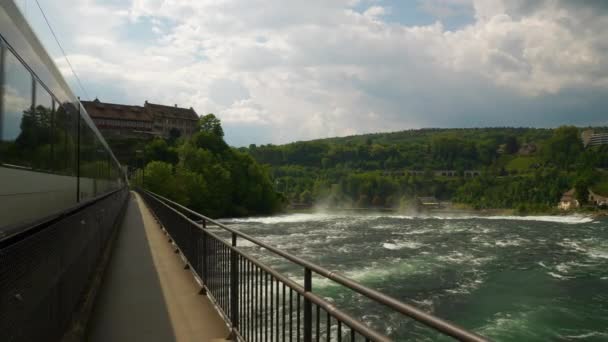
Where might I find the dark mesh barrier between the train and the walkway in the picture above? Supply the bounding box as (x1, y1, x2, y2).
(0, 189, 128, 342)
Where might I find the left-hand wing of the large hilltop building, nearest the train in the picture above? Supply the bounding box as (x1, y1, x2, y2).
(81, 99, 155, 138)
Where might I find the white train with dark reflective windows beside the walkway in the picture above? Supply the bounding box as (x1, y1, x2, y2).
(0, 1, 127, 238)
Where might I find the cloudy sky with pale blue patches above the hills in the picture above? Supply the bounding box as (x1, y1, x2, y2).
(15, 0, 608, 146)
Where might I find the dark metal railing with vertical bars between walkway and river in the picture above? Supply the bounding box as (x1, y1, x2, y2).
(138, 190, 486, 342)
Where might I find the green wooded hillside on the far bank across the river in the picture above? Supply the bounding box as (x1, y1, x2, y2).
(241, 126, 608, 212)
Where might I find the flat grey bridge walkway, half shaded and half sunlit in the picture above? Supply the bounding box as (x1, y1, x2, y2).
(86, 192, 229, 342)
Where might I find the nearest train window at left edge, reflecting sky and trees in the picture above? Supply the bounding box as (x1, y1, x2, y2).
(0, 52, 34, 167)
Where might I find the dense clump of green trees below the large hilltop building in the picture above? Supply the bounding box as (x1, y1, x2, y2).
(131, 114, 284, 217)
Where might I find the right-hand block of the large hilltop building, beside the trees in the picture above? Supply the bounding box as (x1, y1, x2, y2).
(144, 101, 199, 137)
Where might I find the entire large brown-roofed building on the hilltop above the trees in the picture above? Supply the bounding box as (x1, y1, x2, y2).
(82, 98, 199, 139)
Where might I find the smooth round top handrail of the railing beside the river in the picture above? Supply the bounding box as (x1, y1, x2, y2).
(143, 189, 487, 342)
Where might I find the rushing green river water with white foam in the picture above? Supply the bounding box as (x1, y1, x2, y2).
(220, 214, 608, 341)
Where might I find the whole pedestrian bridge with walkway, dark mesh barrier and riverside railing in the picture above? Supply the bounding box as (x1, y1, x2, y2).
(0, 189, 485, 342)
